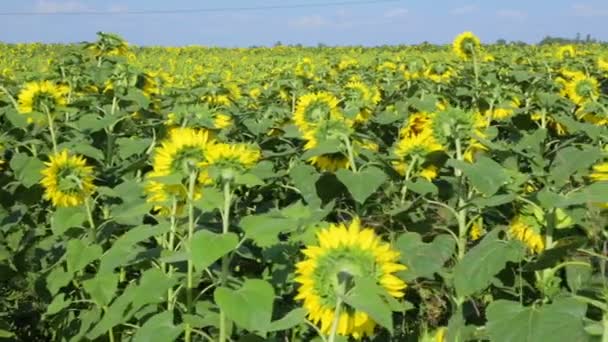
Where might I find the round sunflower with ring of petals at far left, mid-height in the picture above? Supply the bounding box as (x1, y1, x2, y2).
(40, 150, 95, 207)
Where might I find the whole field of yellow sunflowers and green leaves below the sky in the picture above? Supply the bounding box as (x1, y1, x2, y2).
(0, 32, 608, 342)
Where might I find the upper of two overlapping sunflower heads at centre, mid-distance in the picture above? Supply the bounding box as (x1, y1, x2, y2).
(293, 92, 345, 132)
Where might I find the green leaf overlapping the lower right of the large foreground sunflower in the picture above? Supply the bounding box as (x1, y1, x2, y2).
(344, 278, 393, 333)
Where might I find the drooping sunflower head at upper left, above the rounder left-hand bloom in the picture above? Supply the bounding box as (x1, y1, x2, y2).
(17, 81, 69, 114)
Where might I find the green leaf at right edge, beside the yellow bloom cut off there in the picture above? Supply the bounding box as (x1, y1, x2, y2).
(549, 146, 602, 185)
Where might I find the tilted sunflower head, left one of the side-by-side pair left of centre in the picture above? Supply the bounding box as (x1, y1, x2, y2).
(153, 128, 213, 178)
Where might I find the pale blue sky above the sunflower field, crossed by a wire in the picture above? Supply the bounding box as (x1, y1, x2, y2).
(0, 0, 608, 47)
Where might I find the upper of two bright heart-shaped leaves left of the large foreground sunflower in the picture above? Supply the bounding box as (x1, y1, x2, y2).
(192, 230, 239, 270)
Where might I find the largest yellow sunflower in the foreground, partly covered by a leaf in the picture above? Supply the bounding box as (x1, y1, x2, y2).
(295, 218, 406, 339)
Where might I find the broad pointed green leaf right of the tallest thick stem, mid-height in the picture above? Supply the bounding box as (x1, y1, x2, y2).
(448, 156, 509, 196)
